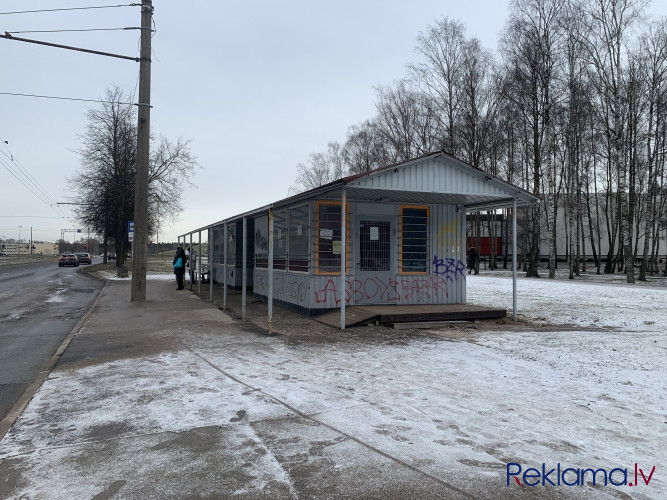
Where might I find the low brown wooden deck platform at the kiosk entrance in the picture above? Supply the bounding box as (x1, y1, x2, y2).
(313, 304, 507, 328)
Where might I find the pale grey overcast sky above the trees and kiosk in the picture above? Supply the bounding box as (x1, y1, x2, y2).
(0, 0, 667, 241)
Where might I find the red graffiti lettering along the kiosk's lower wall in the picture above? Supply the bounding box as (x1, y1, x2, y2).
(315, 275, 449, 305)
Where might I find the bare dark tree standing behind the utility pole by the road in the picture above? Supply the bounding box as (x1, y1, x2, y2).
(71, 87, 196, 267)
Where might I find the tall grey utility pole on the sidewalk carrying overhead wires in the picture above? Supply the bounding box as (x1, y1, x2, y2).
(130, 0, 153, 302)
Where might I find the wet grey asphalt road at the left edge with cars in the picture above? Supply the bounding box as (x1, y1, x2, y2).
(0, 257, 104, 419)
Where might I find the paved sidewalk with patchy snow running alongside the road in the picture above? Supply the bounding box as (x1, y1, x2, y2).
(0, 281, 480, 499)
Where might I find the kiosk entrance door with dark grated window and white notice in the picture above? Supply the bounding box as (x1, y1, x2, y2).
(351, 218, 397, 304)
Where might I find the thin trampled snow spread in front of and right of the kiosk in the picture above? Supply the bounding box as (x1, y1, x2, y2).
(0, 275, 667, 498)
